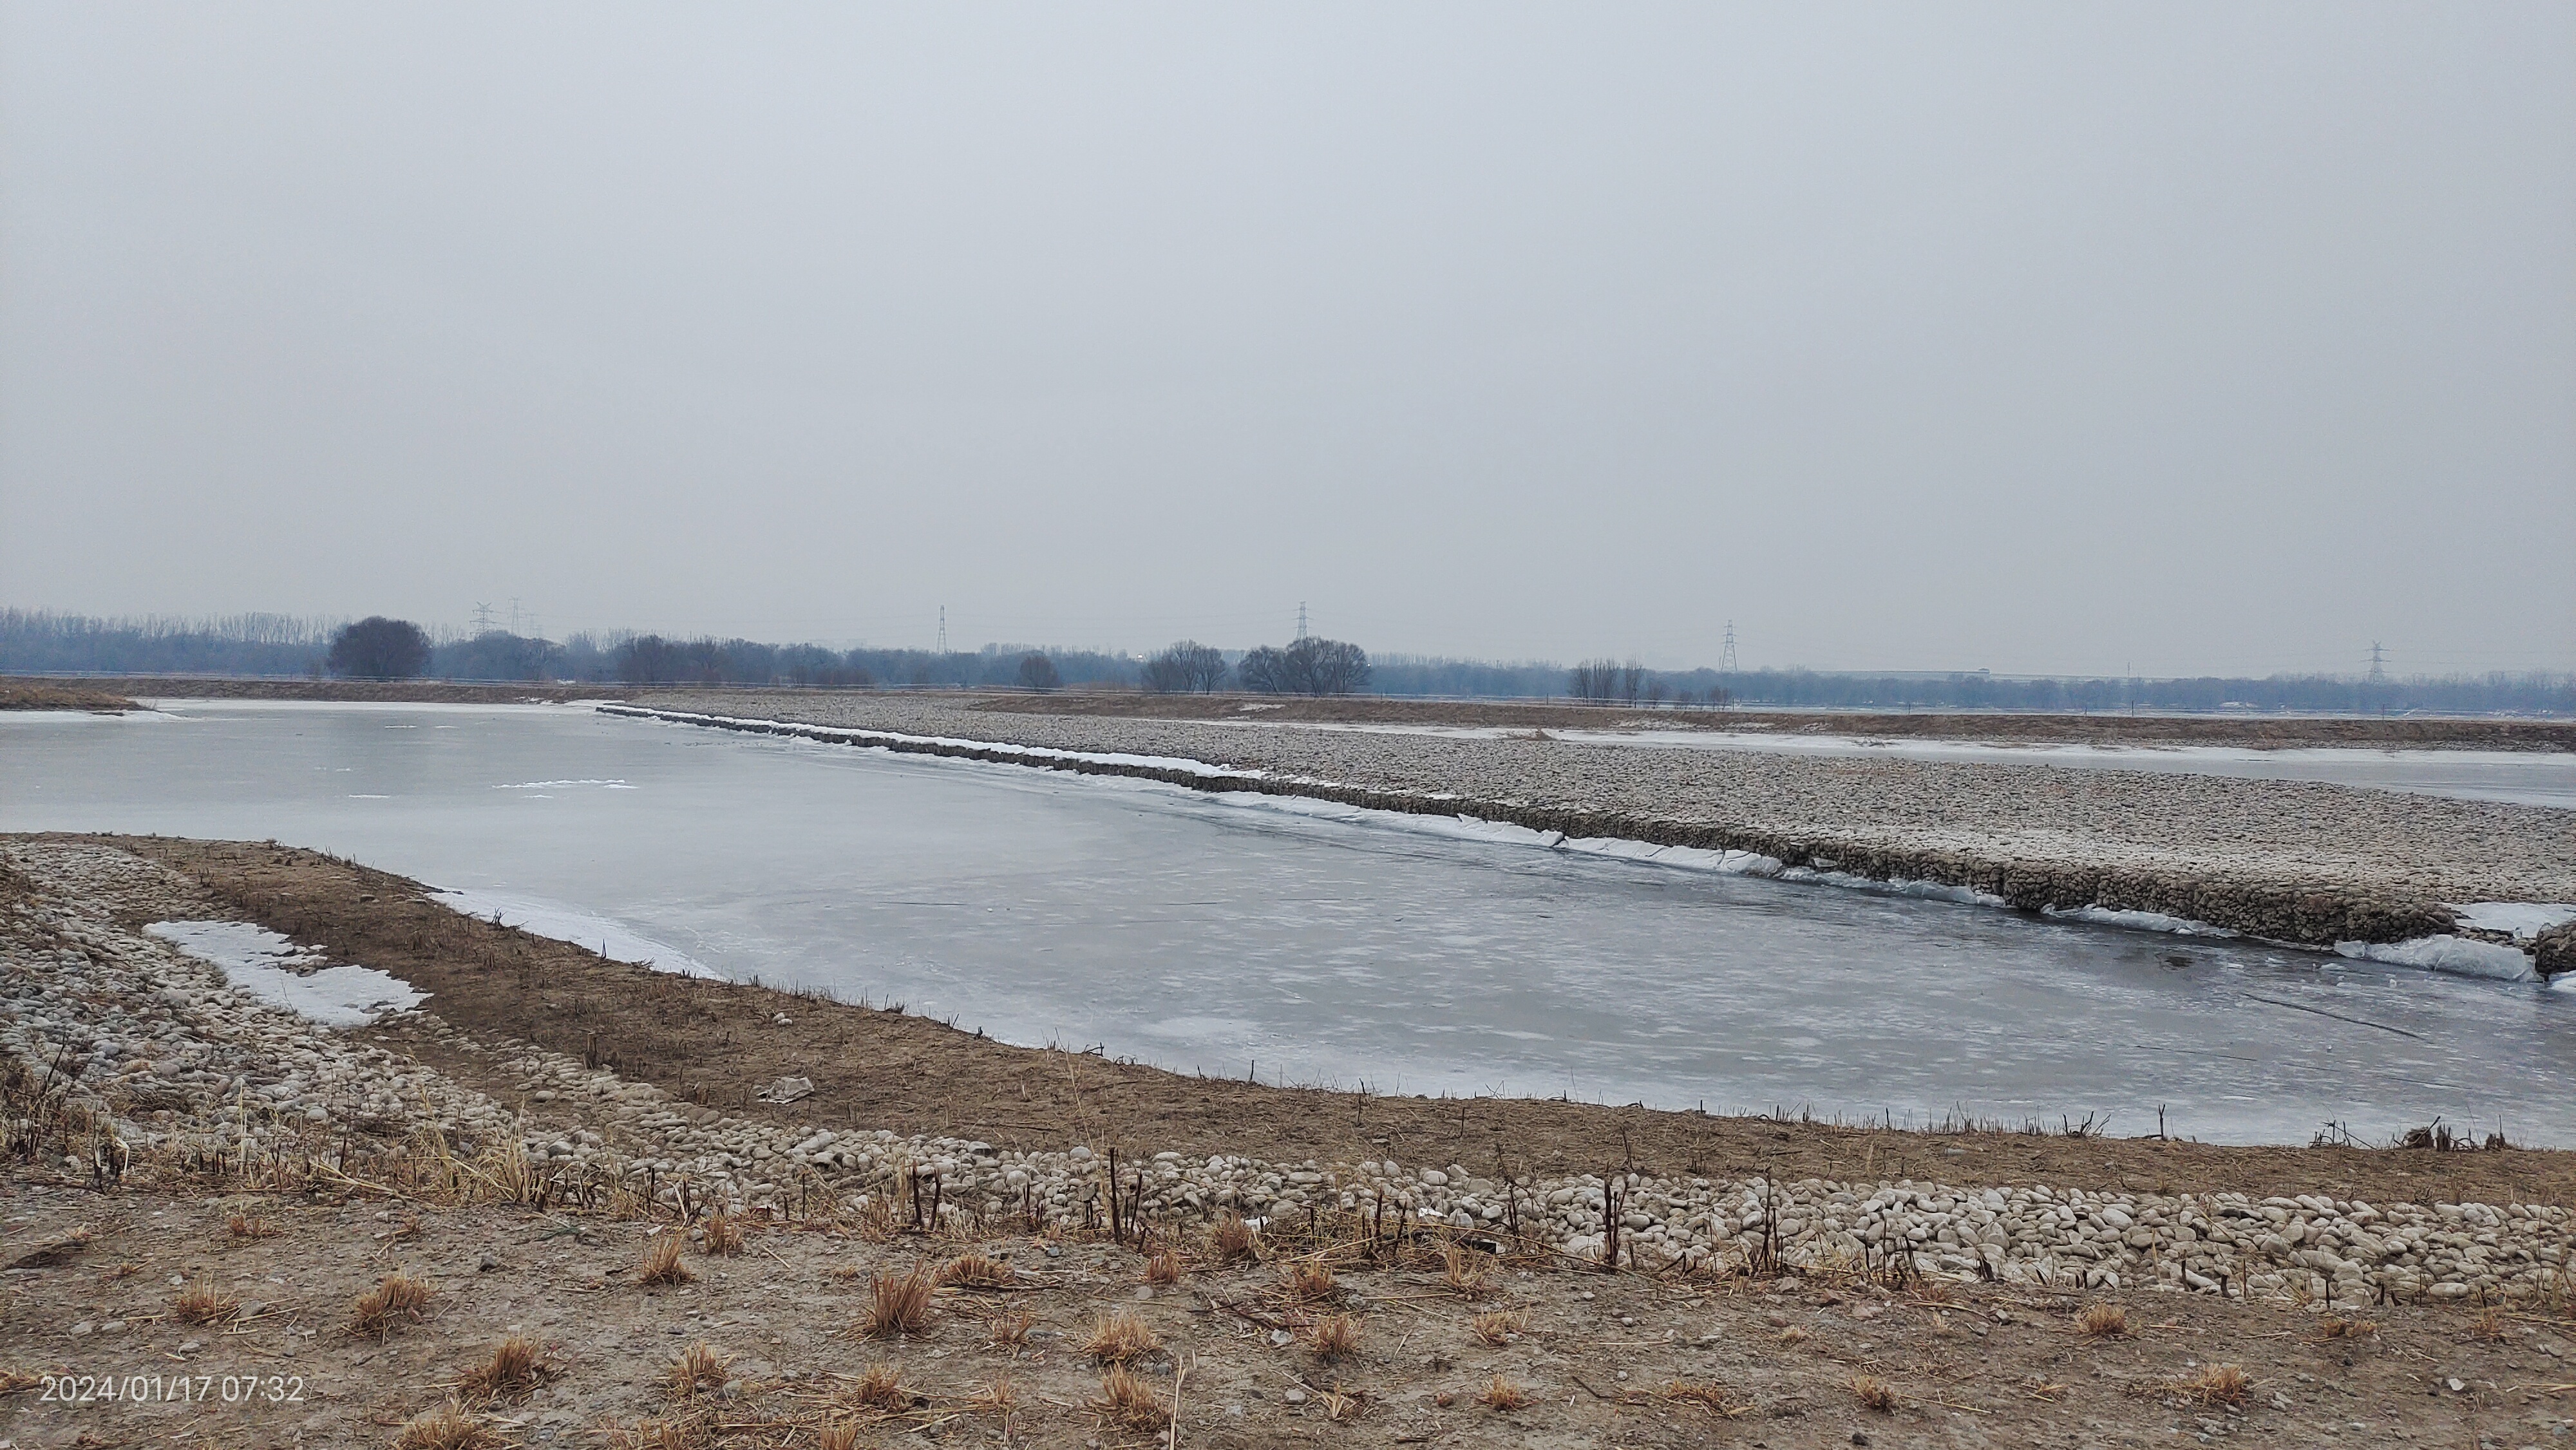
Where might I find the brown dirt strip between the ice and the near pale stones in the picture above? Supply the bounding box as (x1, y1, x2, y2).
(91, 837, 2576, 1226)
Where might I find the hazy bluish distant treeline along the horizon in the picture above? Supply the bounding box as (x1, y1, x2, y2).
(0, 610, 2576, 716)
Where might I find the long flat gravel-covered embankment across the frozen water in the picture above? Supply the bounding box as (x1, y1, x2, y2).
(603, 695, 2576, 961)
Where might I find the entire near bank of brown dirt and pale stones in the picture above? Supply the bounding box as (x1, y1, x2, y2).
(0, 837, 2576, 1447)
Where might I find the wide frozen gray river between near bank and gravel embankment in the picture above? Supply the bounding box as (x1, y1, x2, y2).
(0, 701, 2576, 1144)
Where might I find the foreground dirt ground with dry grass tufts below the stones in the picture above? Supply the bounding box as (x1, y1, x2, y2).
(0, 1174, 2576, 1450)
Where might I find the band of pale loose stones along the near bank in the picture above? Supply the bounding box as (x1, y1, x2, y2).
(0, 845, 2576, 1303)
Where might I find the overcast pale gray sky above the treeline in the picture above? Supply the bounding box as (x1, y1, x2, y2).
(0, 0, 2576, 675)
